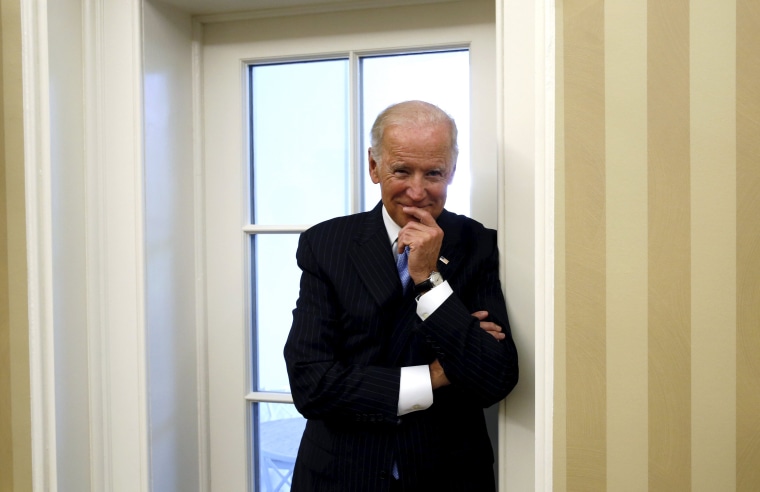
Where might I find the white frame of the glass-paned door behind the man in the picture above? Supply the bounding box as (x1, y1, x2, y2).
(200, 2, 497, 490)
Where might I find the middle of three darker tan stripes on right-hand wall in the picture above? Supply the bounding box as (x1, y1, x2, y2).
(647, 0, 691, 492)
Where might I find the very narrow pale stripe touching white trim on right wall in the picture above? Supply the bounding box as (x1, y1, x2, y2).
(552, 2, 567, 492)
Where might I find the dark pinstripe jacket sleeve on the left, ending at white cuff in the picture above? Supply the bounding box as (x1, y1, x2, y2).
(285, 234, 401, 422)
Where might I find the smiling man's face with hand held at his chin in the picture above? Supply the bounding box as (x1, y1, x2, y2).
(369, 124, 455, 227)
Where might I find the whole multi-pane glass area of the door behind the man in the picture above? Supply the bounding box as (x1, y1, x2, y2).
(246, 49, 470, 491)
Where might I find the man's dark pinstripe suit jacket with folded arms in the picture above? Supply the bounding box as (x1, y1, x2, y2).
(285, 204, 518, 492)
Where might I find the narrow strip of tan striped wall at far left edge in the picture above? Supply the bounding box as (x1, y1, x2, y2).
(0, 0, 32, 492)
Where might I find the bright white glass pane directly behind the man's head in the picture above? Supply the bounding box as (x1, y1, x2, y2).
(361, 50, 470, 215)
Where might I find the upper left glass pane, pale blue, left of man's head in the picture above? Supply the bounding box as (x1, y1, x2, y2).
(251, 60, 349, 224)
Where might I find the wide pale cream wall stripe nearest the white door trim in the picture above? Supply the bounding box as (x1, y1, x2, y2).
(604, 0, 649, 490)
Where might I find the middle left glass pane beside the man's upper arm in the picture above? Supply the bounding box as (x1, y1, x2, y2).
(252, 234, 301, 393)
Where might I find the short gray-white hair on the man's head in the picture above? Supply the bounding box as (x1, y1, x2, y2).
(369, 101, 459, 165)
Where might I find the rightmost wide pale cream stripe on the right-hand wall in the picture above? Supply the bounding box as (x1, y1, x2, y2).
(690, 0, 736, 492)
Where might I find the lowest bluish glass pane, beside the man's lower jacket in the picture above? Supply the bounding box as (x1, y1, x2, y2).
(254, 403, 306, 492)
